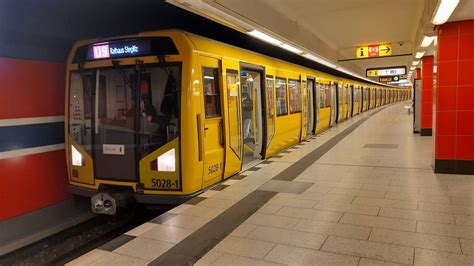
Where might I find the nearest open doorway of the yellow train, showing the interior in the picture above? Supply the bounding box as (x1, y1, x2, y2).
(240, 65, 264, 164)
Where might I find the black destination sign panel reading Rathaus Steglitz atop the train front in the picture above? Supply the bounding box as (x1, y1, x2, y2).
(81, 37, 179, 61)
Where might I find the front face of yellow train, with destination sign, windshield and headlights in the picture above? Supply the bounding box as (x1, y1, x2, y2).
(65, 31, 196, 214)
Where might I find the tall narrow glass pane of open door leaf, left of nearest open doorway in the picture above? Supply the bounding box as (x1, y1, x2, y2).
(226, 69, 242, 158)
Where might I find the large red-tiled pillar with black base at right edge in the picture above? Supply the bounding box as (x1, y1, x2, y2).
(434, 20, 474, 174)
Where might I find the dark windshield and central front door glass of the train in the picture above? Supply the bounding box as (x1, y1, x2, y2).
(69, 65, 181, 179)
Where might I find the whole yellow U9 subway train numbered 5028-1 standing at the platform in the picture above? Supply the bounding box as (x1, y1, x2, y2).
(65, 30, 411, 214)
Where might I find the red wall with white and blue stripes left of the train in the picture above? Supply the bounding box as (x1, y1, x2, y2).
(0, 58, 69, 221)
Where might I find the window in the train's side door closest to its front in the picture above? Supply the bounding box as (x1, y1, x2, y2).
(202, 67, 221, 118)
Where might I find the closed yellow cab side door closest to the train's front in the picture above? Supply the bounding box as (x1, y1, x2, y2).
(199, 56, 225, 186)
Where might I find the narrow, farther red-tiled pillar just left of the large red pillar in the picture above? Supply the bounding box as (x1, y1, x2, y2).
(420, 56, 434, 136)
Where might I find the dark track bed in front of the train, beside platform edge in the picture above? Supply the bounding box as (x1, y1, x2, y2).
(0, 202, 166, 265)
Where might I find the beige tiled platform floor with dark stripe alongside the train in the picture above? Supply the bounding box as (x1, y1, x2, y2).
(69, 102, 474, 265)
